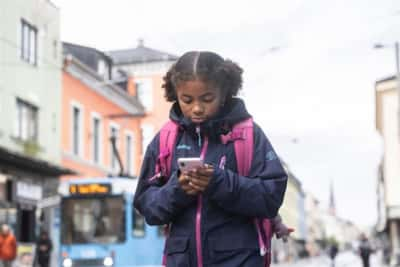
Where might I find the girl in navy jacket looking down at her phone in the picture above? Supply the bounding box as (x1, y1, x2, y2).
(134, 51, 287, 267)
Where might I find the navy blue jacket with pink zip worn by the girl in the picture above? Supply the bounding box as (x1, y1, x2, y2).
(134, 99, 287, 267)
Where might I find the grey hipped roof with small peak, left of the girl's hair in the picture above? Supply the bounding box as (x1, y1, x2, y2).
(107, 42, 178, 65)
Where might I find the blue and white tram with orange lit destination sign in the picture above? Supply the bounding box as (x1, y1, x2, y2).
(59, 177, 164, 267)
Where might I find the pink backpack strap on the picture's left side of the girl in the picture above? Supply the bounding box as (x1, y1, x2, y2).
(156, 120, 179, 179)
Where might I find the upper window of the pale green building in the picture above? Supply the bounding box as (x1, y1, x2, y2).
(20, 19, 37, 65)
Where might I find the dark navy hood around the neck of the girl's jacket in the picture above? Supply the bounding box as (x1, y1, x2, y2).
(169, 98, 251, 138)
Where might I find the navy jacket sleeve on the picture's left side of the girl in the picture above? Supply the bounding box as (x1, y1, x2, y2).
(134, 135, 195, 225)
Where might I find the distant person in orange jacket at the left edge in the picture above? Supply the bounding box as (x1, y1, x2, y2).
(0, 224, 17, 267)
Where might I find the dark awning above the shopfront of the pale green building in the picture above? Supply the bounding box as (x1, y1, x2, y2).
(0, 147, 76, 177)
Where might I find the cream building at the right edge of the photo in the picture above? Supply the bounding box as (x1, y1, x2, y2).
(375, 77, 400, 266)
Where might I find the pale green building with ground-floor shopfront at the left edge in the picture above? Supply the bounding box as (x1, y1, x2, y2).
(0, 0, 73, 264)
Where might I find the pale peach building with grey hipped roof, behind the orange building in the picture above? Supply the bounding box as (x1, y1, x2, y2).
(107, 40, 178, 155)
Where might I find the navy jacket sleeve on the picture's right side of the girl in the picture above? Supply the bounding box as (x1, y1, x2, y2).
(206, 124, 287, 218)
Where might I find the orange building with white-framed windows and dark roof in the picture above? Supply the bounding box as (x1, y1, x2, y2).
(62, 43, 144, 177)
